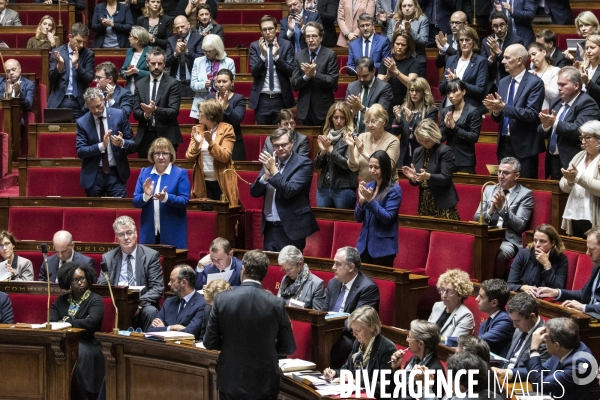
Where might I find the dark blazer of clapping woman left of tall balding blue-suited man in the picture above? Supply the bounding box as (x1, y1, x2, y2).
(440, 53, 488, 114)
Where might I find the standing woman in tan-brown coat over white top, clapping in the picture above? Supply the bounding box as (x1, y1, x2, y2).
(185, 99, 239, 206)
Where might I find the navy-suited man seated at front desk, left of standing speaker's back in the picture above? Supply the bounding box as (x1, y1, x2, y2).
(148, 265, 206, 340)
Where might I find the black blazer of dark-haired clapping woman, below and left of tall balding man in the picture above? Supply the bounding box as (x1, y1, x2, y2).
(440, 102, 481, 167)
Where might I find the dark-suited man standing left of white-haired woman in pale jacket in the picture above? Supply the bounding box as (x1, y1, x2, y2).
(167, 15, 204, 97)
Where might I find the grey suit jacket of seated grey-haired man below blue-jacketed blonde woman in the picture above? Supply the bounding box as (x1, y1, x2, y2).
(98, 244, 165, 308)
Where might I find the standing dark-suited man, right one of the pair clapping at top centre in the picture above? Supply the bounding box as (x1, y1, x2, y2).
(290, 21, 339, 126)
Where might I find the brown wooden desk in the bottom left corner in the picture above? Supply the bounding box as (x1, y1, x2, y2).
(0, 325, 83, 400)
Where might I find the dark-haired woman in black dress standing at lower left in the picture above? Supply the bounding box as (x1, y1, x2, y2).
(50, 262, 104, 399)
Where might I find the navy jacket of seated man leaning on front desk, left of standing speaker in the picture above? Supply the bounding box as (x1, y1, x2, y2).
(148, 291, 206, 340)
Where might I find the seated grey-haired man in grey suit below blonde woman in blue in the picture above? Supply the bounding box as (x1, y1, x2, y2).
(98, 215, 165, 332)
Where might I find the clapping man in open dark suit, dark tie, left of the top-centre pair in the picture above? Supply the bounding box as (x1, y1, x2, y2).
(249, 15, 296, 125)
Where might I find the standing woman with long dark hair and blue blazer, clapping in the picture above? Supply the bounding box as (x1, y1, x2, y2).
(354, 150, 402, 267)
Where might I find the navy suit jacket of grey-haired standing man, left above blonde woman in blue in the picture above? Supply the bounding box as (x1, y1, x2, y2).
(76, 108, 137, 189)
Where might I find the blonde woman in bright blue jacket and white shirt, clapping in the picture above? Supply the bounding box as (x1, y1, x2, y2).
(133, 137, 190, 249)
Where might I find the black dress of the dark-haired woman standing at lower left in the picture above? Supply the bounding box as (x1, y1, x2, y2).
(50, 292, 104, 393)
